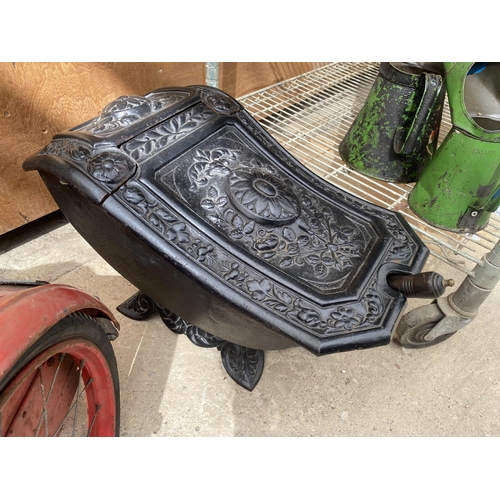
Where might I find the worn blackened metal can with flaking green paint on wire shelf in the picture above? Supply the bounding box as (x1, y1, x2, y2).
(339, 62, 445, 182)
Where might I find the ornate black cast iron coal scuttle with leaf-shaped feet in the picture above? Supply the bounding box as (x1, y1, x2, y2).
(24, 86, 438, 390)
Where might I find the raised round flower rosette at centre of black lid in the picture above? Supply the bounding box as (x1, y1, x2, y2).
(230, 170, 299, 224)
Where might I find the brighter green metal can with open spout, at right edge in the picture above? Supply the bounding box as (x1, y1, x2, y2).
(408, 62, 500, 233)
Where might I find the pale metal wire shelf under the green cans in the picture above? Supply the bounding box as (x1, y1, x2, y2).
(239, 63, 500, 274)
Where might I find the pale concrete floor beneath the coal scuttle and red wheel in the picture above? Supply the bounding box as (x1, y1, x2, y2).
(0, 209, 500, 437)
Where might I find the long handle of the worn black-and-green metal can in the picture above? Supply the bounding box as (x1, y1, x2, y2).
(394, 73, 443, 154)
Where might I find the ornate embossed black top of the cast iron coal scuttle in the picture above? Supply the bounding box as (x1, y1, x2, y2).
(24, 86, 428, 354)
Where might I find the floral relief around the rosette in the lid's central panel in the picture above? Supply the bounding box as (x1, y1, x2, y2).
(188, 148, 370, 289)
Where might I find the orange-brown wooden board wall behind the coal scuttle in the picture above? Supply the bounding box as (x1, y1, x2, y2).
(0, 62, 325, 234)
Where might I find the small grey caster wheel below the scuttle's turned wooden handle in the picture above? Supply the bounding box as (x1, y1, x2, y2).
(394, 303, 456, 349)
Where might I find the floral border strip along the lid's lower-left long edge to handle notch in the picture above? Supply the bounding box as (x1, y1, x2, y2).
(118, 183, 388, 337)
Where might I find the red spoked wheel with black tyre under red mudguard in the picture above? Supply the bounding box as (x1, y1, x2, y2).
(0, 313, 120, 437)
